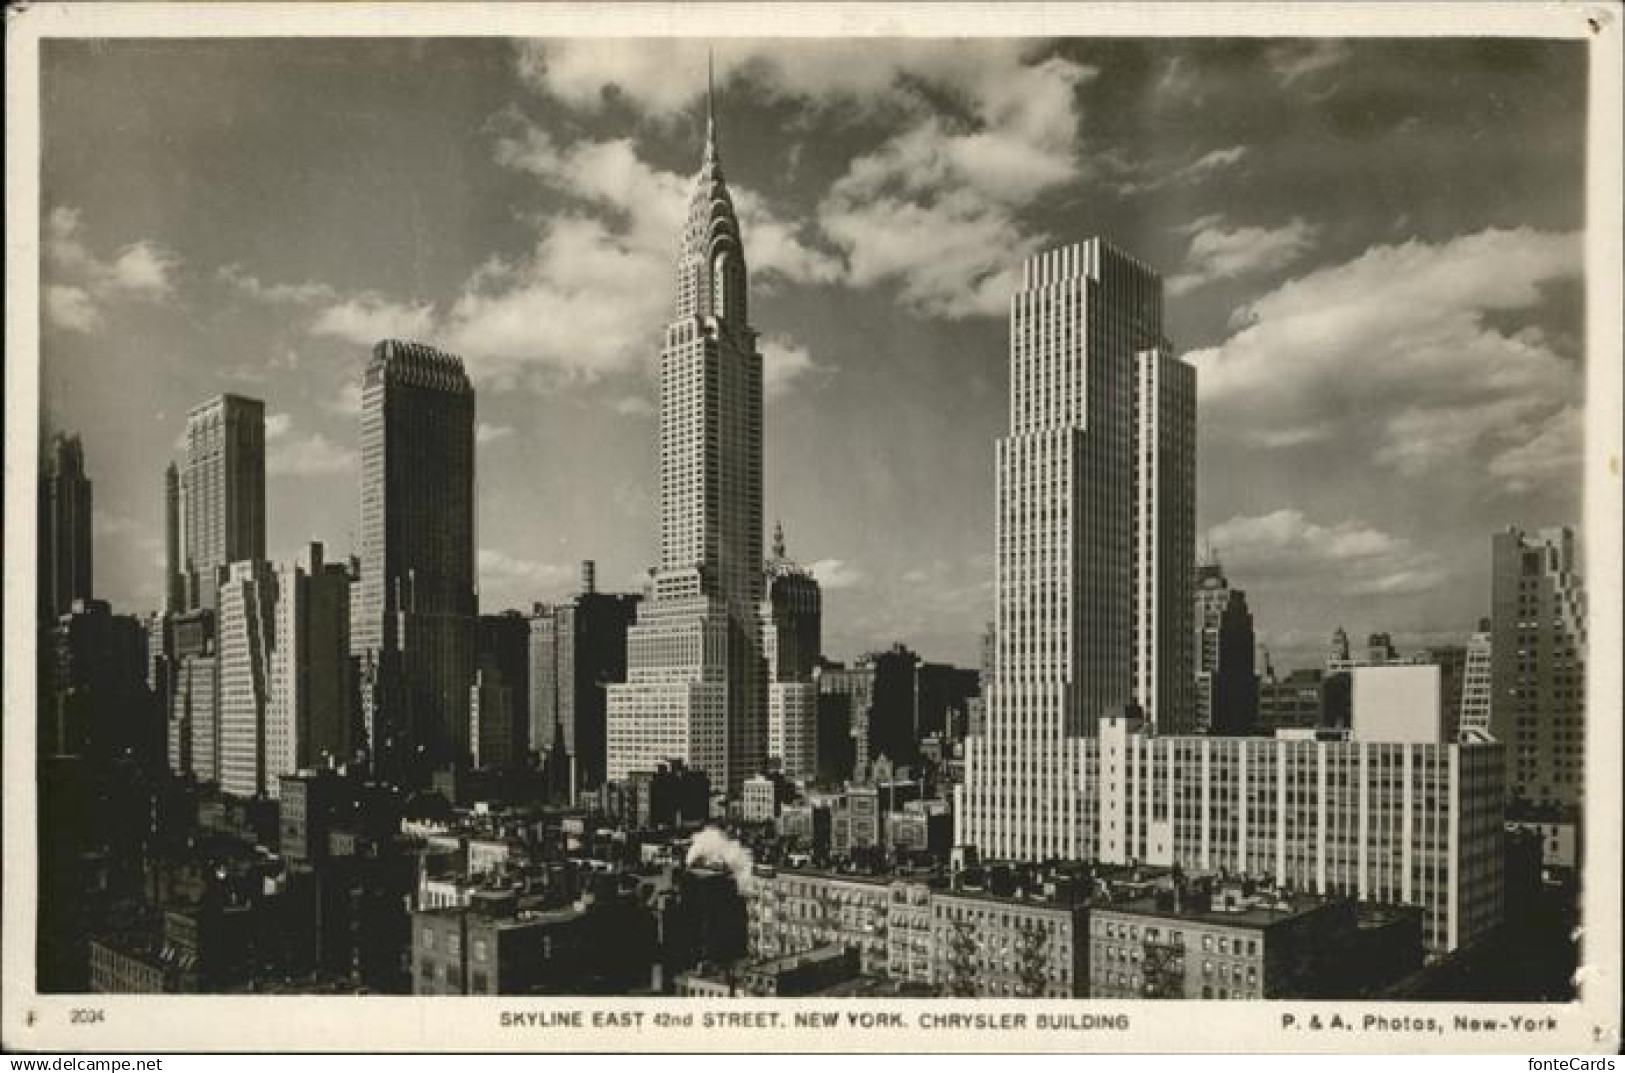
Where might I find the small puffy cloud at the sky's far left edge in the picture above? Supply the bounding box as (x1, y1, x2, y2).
(44, 206, 180, 333)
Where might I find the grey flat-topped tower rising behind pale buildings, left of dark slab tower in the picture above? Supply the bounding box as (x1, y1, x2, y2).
(180, 395, 265, 610)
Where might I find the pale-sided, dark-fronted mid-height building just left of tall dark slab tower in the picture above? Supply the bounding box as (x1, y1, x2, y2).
(265, 543, 354, 795)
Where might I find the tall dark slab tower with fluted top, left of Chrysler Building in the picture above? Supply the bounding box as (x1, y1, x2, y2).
(351, 340, 476, 784)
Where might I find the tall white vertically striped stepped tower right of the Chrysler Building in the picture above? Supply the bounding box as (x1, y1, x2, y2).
(957, 239, 1196, 858)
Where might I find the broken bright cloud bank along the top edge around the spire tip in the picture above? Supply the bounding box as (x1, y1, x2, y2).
(520, 41, 1095, 317)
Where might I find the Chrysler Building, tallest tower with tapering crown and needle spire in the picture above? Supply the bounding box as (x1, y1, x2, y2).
(608, 92, 767, 792)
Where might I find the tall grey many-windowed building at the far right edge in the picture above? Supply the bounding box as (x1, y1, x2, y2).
(1490, 528, 1586, 806)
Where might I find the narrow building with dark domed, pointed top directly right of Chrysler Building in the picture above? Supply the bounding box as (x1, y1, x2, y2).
(762, 525, 824, 780)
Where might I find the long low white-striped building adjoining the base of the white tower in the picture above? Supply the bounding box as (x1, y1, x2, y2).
(1081, 719, 1503, 953)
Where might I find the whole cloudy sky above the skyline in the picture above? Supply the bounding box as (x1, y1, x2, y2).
(41, 37, 1586, 670)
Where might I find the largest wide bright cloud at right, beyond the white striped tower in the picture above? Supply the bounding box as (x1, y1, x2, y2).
(1190, 229, 1581, 480)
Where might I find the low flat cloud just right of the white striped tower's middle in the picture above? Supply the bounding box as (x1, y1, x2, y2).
(1207, 509, 1445, 597)
